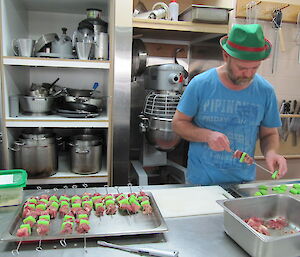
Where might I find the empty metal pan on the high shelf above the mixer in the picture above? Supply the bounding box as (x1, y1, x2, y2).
(178, 4, 233, 24)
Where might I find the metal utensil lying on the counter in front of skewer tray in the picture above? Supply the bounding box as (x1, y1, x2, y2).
(97, 241, 179, 257)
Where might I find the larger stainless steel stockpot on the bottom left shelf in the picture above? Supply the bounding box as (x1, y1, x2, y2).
(11, 128, 58, 178)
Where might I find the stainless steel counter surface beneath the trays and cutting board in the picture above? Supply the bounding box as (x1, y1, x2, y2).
(0, 185, 249, 257)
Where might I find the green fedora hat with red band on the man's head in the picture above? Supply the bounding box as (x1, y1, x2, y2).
(220, 24, 272, 61)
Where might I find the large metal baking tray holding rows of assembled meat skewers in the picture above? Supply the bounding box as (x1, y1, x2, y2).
(1, 192, 168, 242)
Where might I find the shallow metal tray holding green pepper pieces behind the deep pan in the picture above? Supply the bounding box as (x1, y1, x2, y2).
(229, 180, 300, 200)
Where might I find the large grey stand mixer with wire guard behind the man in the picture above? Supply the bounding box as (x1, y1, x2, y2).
(132, 63, 185, 185)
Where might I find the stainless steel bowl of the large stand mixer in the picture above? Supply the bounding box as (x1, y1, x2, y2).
(146, 117, 181, 152)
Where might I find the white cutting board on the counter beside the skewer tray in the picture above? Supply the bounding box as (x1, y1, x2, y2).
(151, 186, 233, 218)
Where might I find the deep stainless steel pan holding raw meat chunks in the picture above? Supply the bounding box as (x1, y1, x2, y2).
(217, 195, 300, 257)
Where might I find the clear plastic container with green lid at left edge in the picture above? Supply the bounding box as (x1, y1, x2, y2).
(0, 170, 27, 207)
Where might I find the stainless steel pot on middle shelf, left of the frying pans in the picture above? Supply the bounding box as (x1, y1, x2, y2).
(19, 96, 55, 114)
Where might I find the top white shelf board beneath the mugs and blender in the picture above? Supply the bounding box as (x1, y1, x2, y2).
(3, 56, 110, 69)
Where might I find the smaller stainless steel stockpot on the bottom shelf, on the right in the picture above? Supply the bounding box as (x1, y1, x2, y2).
(69, 134, 102, 175)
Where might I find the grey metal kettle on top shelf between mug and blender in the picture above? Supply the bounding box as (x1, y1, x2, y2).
(51, 28, 72, 58)
